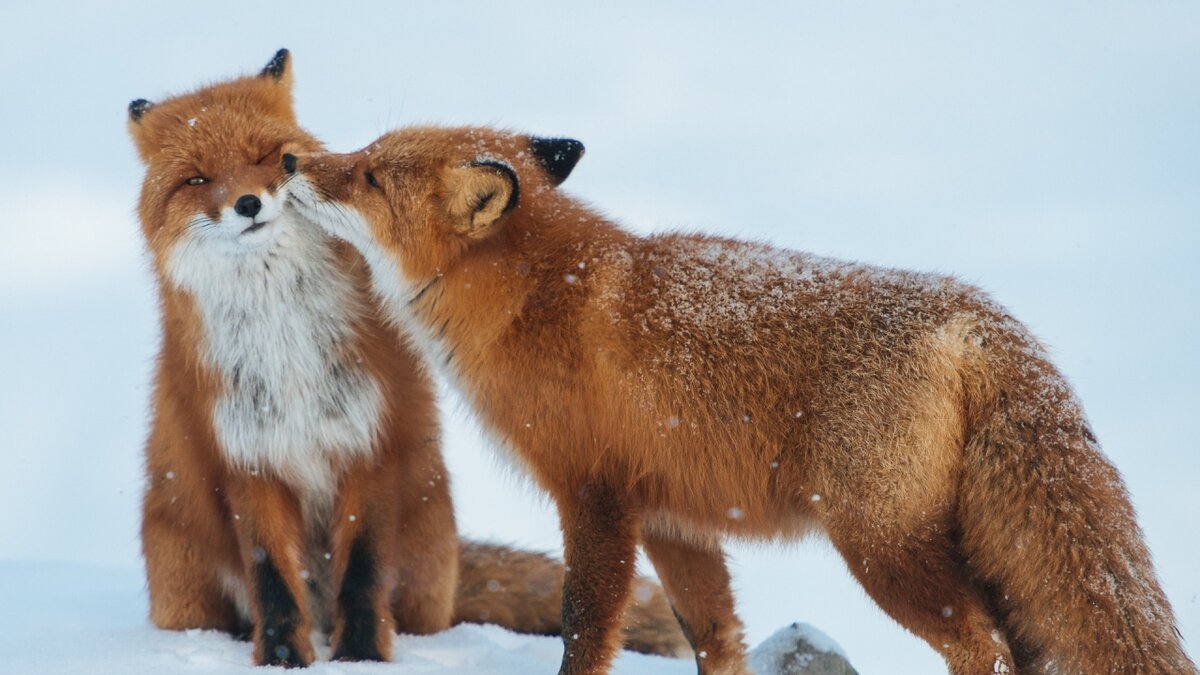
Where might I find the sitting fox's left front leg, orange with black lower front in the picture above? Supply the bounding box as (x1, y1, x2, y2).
(229, 474, 314, 667)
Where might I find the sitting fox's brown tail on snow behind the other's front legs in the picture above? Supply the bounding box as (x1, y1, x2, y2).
(454, 540, 691, 657)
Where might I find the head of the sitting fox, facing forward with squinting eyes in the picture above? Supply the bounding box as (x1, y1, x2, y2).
(128, 49, 320, 256)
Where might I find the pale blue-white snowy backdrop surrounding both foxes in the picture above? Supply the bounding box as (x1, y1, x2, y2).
(0, 0, 1200, 674)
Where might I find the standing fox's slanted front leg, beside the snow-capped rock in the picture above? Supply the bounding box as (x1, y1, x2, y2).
(642, 532, 746, 675)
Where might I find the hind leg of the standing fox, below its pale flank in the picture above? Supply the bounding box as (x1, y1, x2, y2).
(829, 511, 1012, 675)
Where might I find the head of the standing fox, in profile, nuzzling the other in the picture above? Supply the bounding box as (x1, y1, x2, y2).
(283, 127, 583, 282)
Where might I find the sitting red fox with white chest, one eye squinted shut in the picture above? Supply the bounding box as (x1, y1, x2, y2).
(128, 50, 686, 665)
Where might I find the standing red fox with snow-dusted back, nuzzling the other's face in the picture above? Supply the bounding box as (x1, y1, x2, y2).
(282, 127, 1195, 675)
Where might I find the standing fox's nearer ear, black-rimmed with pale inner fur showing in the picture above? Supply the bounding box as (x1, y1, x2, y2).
(445, 160, 521, 239)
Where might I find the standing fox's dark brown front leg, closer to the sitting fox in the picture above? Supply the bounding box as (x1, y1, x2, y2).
(557, 485, 638, 675)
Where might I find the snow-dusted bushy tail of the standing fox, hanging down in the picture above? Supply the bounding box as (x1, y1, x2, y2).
(960, 335, 1196, 675)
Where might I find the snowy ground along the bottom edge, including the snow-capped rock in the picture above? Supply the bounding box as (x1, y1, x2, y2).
(0, 562, 845, 675)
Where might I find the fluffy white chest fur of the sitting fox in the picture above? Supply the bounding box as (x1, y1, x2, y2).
(167, 213, 383, 496)
